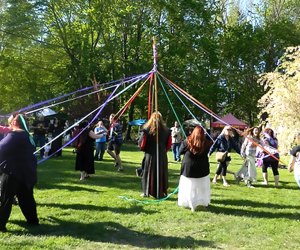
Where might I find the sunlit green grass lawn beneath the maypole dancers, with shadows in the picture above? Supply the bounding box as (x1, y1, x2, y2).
(0, 145, 300, 250)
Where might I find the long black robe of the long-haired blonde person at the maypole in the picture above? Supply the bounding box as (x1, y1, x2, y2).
(142, 128, 171, 198)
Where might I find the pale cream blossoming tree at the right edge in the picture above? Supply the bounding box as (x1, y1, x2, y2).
(259, 46, 300, 152)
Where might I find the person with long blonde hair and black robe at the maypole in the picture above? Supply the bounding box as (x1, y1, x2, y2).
(139, 112, 172, 199)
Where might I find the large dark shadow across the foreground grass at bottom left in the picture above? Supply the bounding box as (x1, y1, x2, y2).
(12, 217, 216, 249)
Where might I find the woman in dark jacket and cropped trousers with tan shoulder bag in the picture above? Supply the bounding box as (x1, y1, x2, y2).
(208, 126, 240, 187)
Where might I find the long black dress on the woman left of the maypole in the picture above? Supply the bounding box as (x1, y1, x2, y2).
(75, 129, 95, 174)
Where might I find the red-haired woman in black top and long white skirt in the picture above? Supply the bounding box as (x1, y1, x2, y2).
(178, 126, 212, 212)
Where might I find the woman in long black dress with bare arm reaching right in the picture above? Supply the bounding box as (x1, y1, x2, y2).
(75, 121, 104, 181)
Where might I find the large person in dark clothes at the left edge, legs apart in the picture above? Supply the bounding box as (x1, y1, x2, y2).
(0, 114, 39, 231)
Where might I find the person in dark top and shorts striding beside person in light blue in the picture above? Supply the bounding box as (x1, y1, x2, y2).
(107, 114, 124, 171)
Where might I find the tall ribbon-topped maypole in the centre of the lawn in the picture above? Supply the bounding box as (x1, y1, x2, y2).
(152, 37, 159, 199)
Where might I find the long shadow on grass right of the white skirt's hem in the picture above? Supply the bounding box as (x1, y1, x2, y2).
(207, 200, 300, 220)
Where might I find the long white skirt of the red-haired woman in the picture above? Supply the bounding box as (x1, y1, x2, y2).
(178, 175, 210, 210)
